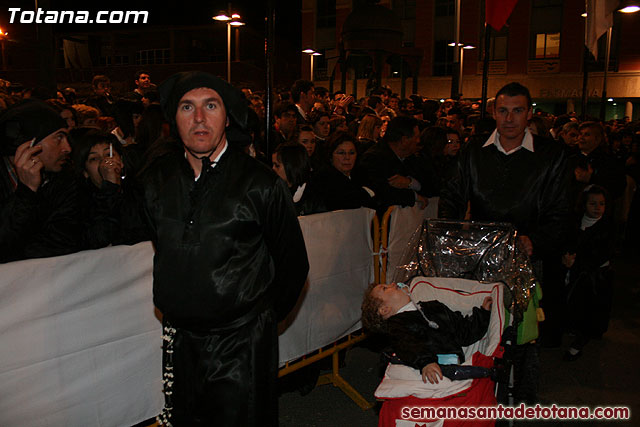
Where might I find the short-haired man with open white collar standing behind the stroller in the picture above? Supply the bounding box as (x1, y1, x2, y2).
(438, 83, 569, 402)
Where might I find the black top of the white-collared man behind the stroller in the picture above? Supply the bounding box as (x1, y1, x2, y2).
(438, 136, 569, 257)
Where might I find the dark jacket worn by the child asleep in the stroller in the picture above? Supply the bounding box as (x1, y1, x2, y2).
(387, 301, 491, 370)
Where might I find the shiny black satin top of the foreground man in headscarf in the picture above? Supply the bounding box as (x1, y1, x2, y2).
(143, 145, 309, 330)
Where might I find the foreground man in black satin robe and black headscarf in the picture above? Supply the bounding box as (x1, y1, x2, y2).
(142, 71, 309, 426)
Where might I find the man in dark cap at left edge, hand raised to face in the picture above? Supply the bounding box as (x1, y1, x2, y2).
(0, 100, 79, 262)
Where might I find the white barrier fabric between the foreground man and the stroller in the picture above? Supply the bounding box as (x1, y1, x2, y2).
(280, 208, 375, 365)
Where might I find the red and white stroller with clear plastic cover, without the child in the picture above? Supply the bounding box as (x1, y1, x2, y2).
(375, 220, 542, 427)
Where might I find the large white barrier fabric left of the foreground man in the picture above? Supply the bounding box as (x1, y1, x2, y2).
(0, 242, 163, 427)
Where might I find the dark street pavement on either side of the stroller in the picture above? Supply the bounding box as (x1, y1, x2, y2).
(280, 252, 640, 427)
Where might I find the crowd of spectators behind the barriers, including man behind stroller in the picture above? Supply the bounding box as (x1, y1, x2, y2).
(0, 71, 640, 422)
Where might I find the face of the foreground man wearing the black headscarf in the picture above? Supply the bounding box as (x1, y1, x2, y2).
(176, 87, 227, 157)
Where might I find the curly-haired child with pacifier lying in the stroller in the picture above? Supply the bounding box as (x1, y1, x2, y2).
(362, 283, 494, 384)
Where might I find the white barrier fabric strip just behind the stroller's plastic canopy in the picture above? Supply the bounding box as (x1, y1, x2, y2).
(381, 197, 440, 283)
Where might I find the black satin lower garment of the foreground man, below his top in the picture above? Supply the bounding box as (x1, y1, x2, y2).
(163, 311, 278, 427)
